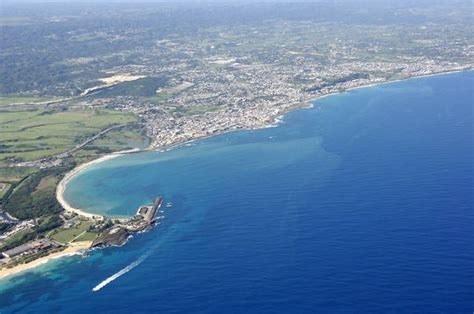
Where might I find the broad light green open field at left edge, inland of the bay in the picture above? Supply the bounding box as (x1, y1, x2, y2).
(0, 109, 138, 163)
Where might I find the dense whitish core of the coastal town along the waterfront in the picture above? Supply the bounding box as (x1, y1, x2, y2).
(137, 60, 470, 149)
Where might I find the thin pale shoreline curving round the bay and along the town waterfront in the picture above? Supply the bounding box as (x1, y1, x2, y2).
(56, 68, 473, 219)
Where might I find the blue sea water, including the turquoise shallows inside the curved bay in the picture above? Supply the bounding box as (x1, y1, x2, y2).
(0, 72, 474, 314)
